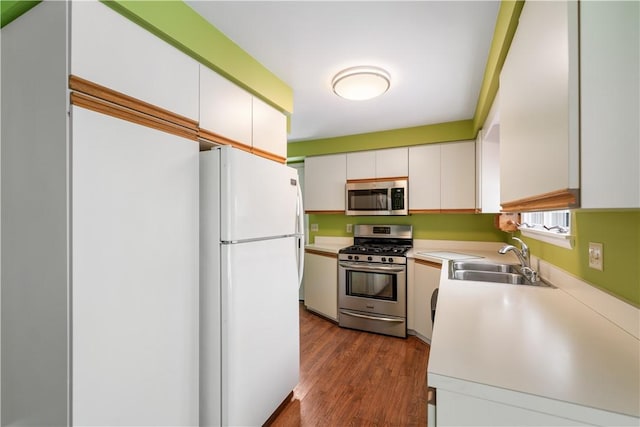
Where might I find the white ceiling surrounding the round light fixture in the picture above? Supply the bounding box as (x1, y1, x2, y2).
(186, 0, 500, 141)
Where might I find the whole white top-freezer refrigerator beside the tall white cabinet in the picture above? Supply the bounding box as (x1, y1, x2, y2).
(200, 146, 304, 426)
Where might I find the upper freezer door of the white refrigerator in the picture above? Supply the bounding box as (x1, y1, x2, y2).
(220, 146, 298, 242)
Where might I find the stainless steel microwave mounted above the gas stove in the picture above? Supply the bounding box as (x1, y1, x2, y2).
(345, 179, 409, 215)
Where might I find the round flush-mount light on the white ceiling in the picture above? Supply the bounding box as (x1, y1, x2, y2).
(331, 66, 391, 101)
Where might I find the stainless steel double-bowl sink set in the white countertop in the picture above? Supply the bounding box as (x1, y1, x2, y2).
(449, 261, 548, 286)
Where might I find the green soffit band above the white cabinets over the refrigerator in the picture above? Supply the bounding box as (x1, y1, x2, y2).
(103, 0, 293, 113)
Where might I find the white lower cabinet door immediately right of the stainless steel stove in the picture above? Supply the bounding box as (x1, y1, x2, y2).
(413, 259, 442, 341)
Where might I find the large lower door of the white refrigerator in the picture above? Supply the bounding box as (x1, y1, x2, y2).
(221, 237, 300, 426)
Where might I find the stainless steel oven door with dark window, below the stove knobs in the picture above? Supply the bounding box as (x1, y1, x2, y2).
(338, 261, 407, 317)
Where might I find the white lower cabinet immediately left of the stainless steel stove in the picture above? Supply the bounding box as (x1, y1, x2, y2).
(302, 250, 338, 321)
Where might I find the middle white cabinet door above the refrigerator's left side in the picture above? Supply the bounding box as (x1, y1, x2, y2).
(200, 65, 252, 147)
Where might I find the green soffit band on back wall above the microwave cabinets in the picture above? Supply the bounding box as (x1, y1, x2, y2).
(287, 120, 475, 158)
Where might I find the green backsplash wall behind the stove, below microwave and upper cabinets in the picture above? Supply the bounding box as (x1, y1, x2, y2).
(309, 214, 507, 242)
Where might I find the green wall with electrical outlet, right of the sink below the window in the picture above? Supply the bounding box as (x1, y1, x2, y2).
(523, 209, 640, 306)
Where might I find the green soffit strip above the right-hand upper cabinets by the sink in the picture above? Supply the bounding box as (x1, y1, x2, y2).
(473, 0, 524, 133)
